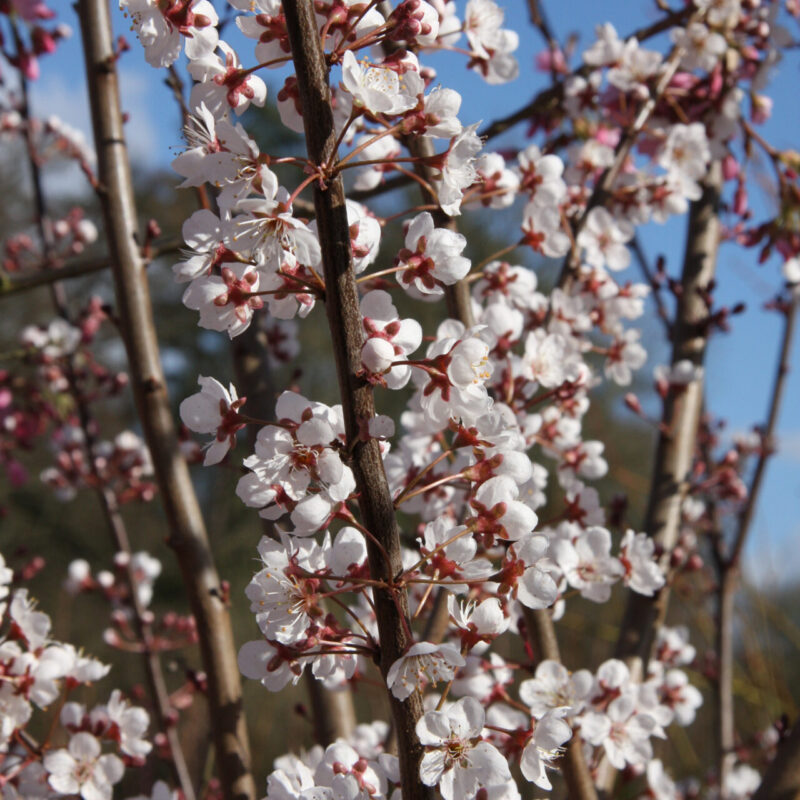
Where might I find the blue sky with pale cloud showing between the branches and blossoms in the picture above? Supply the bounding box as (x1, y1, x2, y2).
(32, 0, 800, 583)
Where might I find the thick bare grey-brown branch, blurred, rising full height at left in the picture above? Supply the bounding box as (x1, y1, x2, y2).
(78, 0, 255, 800)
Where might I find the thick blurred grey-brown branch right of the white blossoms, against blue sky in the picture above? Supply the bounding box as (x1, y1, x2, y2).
(617, 162, 722, 679)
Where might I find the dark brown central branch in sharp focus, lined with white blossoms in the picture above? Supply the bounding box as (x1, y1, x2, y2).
(283, 0, 432, 800)
